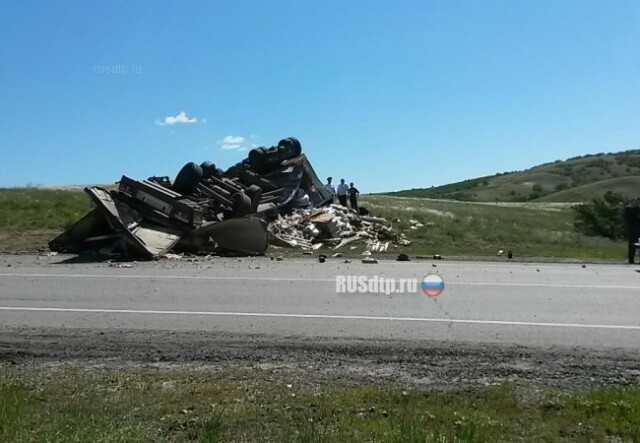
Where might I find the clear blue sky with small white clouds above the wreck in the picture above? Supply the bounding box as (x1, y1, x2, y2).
(0, 0, 640, 192)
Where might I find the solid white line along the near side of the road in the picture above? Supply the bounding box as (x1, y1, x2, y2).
(0, 306, 640, 331)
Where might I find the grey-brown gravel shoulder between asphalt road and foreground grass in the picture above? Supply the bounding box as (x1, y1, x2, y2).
(0, 328, 640, 389)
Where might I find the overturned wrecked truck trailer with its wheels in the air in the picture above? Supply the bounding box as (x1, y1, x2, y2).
(49, 137, 332, 259)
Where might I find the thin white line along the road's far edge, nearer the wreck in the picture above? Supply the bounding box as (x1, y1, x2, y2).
(0, 273, 640, 294)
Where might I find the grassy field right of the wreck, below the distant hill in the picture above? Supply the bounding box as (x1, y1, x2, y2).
(362, 196, 626, 260)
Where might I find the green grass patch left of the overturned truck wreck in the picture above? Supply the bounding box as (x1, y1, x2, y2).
(0, 188, 91, 233)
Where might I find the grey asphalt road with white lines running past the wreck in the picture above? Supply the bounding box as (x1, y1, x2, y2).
(0, 256, 640, 350)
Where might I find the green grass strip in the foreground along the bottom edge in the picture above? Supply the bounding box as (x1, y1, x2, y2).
(0, 368, 640, 443)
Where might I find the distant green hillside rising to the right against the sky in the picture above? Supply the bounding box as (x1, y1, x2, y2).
(386, 149, 640, 202)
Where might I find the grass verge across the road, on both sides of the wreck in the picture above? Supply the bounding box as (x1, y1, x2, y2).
(0, 188, 626, 260)
